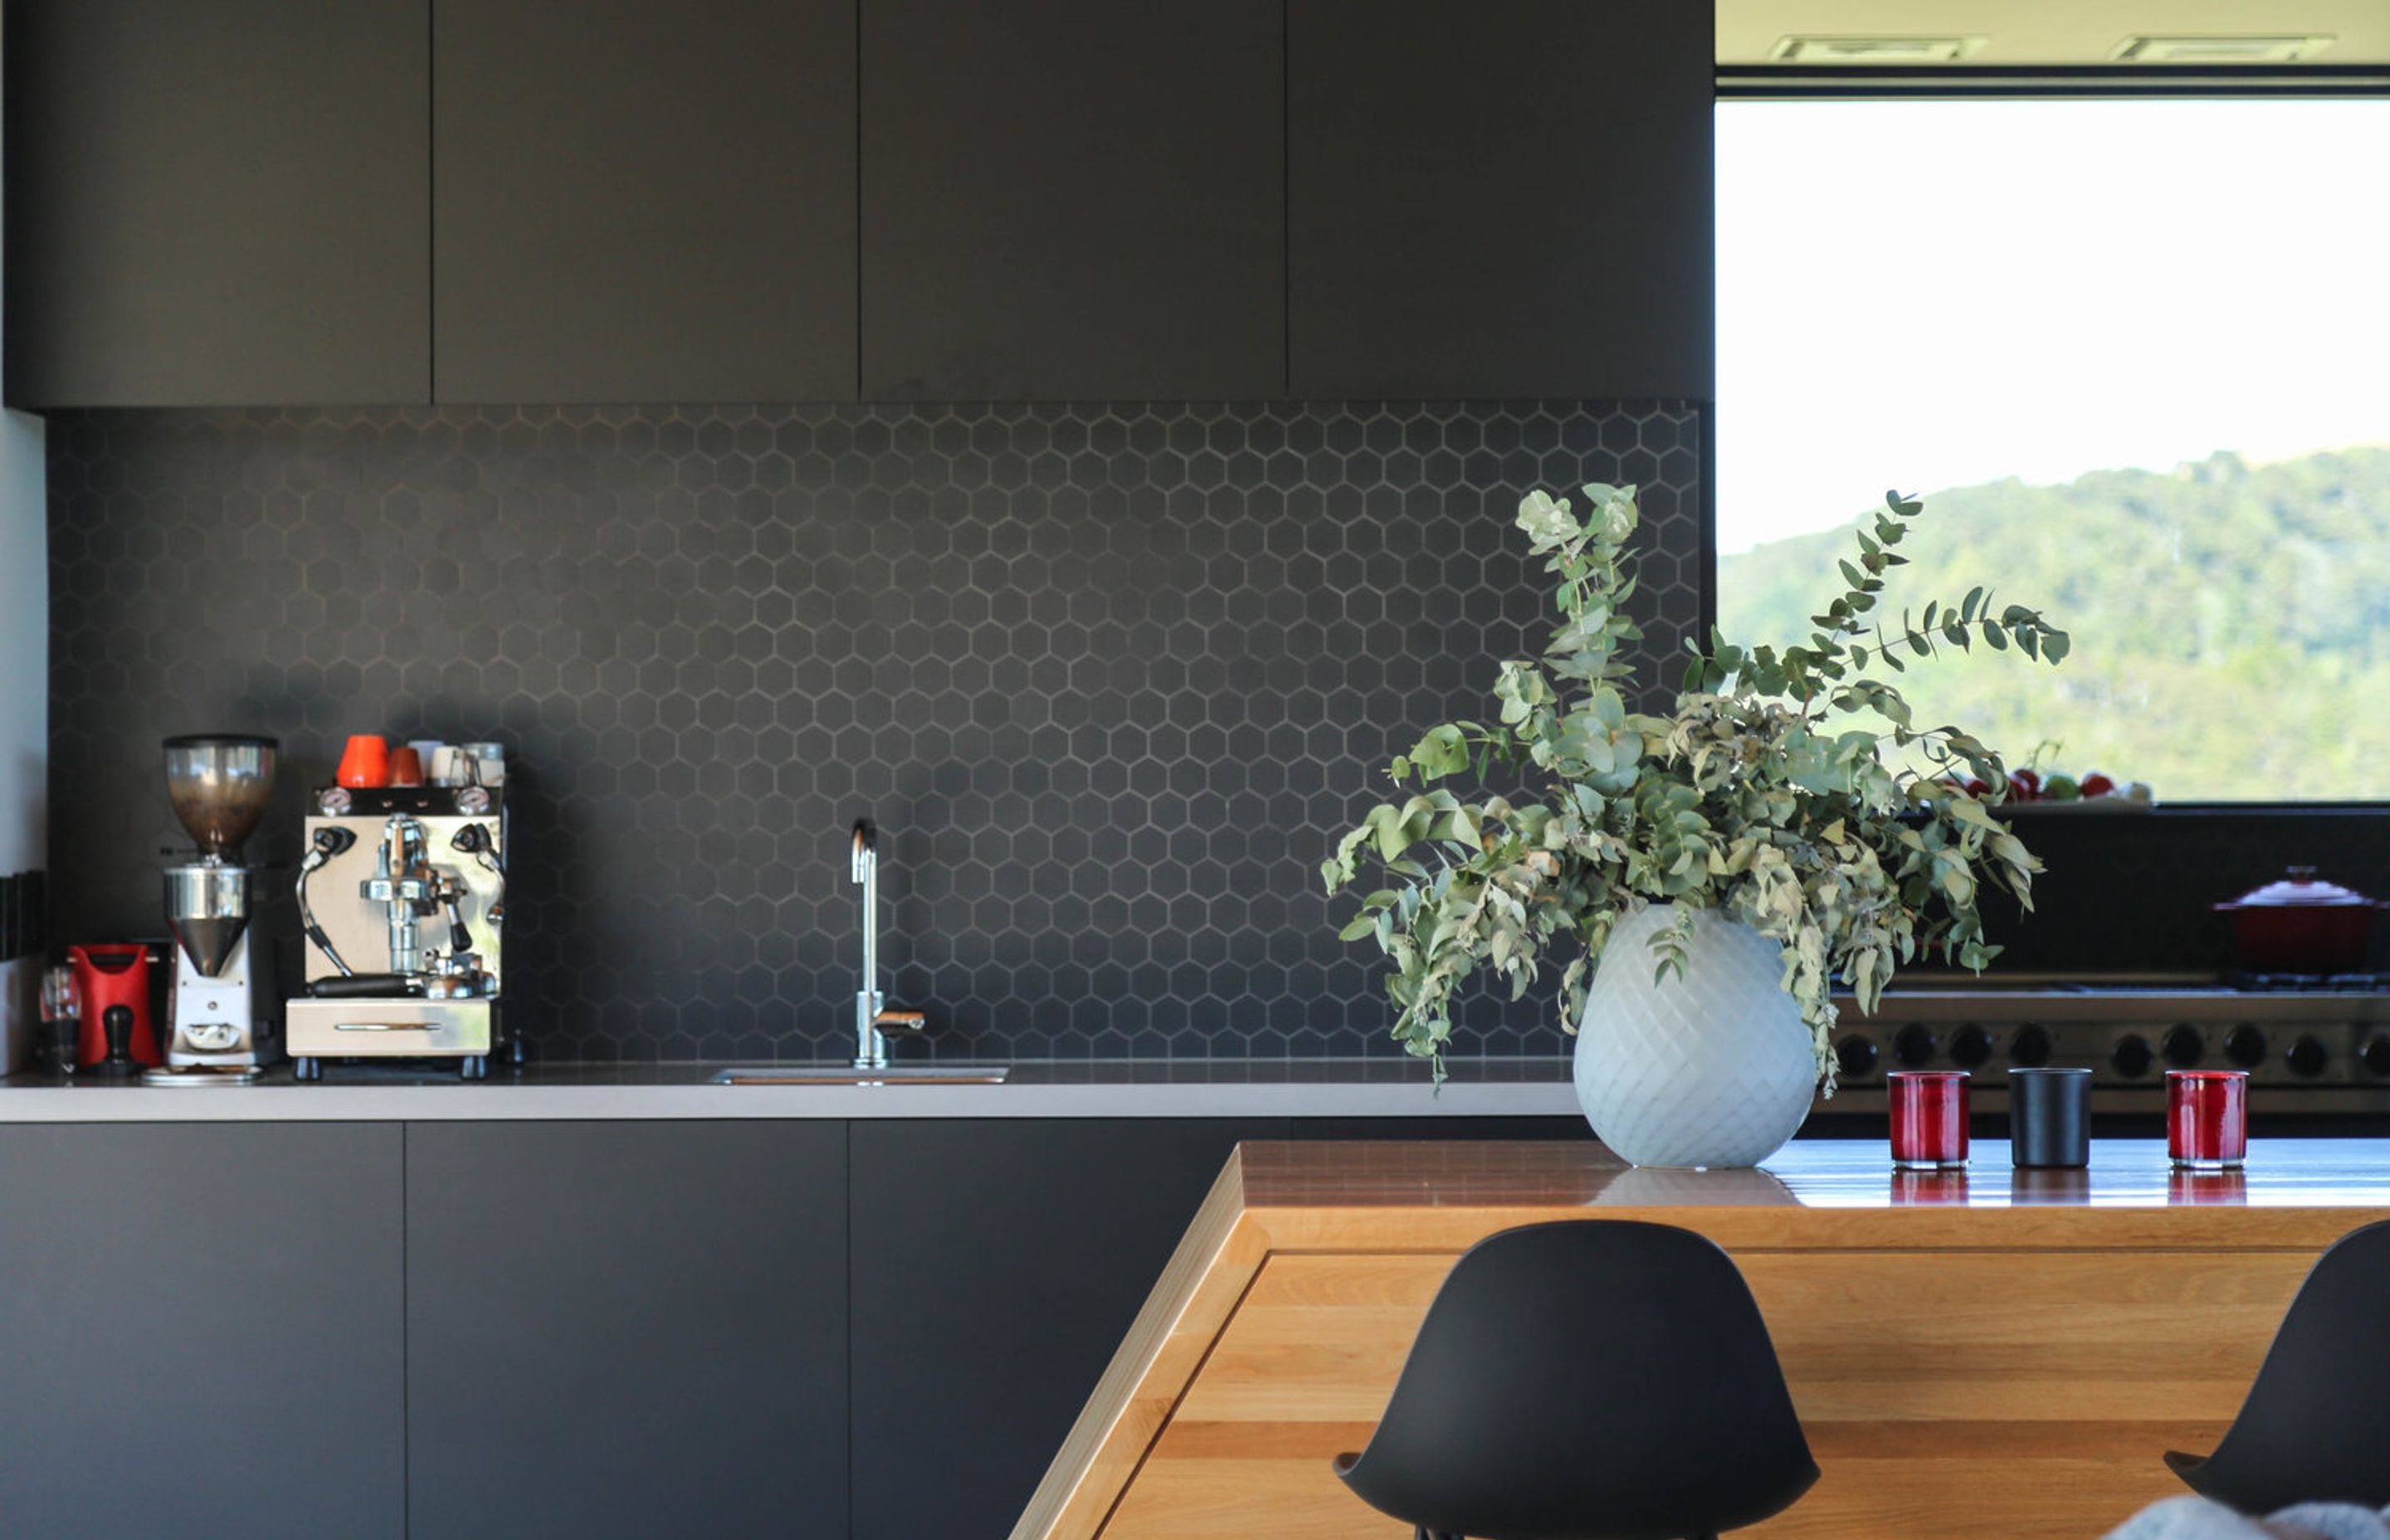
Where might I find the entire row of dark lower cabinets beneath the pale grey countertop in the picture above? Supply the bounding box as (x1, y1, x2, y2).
(0, 1117, 1584, 1540)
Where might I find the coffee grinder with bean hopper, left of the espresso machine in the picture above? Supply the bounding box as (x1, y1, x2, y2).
(141, 732, 282, 1085)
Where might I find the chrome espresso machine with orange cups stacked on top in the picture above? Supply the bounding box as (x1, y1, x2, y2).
(287, 784, 516, 1081)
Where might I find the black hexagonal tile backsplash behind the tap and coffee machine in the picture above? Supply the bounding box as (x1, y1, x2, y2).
(48, 402, 1702, 1060)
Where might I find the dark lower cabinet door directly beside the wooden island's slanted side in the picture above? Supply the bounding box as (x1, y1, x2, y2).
(853, 1119, 1285, 1540)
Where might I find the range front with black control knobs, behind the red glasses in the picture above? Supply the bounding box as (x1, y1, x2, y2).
(1836, 973, 2390, 1107)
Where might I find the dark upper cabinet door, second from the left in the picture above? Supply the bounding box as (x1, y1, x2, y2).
(432, 0, 856, 402)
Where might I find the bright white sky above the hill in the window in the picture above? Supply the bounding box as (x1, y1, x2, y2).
(1719, 100, 2390, 553)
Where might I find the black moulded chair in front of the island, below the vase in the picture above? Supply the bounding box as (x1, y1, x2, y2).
(1336, 1220, 1817, 1540)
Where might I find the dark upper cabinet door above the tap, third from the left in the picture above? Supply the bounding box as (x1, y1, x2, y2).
(863, 0, 1285, 399)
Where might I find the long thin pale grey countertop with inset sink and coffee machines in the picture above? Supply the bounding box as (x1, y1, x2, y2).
(0, 1057, 1578, 1124)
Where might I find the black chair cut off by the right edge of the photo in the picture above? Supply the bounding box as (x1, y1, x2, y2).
(2165, 1220, 2390, 1513)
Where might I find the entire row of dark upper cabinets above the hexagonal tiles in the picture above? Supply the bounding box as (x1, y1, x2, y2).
(5, 0, 1714, 407)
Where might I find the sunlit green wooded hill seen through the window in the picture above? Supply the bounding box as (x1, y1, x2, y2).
(1719, 450, 2390, 801)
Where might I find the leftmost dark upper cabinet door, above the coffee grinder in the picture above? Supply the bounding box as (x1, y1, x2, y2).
(7, 0, 430, 407)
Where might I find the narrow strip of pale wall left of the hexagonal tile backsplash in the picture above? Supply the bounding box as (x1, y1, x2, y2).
(0, 12, 50, 1074)
